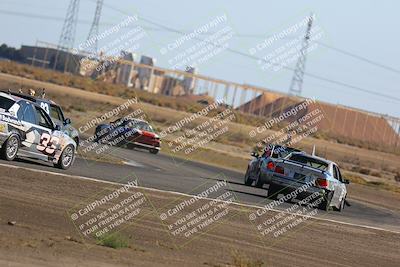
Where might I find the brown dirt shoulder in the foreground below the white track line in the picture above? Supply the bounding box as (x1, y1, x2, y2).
(0, 167, 400, 266)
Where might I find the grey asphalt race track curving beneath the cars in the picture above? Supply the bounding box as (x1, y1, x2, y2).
(0, 148, 400, 232)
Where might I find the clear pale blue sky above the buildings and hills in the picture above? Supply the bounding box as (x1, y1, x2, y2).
(0, 0, 400, 117)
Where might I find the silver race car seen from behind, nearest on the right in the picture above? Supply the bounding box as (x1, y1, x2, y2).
(262, 152, 350, 214)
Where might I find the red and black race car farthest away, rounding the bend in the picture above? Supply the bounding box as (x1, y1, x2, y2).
(95, 118, 161, 154)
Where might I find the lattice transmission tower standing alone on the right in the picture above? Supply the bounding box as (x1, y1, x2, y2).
(289, 14, 314, 96)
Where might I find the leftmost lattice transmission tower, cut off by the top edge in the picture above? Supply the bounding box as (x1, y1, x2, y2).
(58, 0, 79, 50)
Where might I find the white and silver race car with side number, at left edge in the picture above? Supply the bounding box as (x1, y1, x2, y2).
(0, 92, 77, 169)
